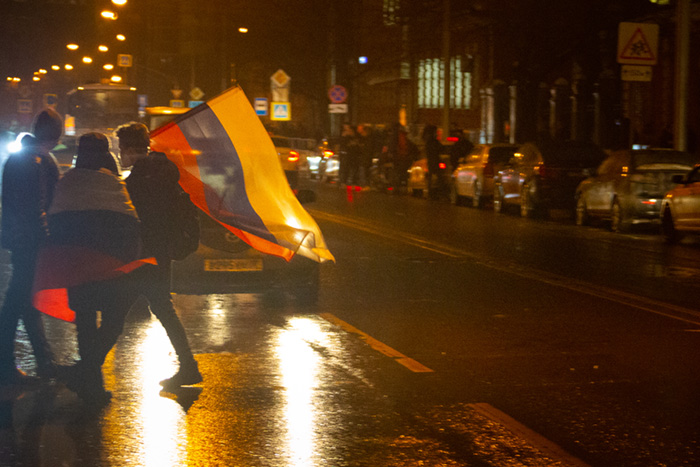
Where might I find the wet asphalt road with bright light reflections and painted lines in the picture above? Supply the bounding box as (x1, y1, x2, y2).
(0, 182, 700, 466)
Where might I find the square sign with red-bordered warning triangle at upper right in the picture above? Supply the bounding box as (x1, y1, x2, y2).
(617, 23, 659, 65)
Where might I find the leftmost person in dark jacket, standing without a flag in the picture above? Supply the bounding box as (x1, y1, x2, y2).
(0, 109, 63, 385)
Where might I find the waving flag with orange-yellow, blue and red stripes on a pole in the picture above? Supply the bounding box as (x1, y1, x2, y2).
(151, 86, 334, 262)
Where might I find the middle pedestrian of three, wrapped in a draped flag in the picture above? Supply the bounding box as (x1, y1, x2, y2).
(45, 133, 144, 406)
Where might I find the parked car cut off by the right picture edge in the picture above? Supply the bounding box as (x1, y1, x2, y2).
(661, 164, 700, 243)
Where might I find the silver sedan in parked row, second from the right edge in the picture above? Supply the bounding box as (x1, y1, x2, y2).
(576, 149, 697, 232)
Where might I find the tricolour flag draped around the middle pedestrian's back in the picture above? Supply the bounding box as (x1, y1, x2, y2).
(33, 169, 155, 321)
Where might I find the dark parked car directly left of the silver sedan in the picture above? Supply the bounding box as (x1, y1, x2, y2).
(493, 141, 606, 217)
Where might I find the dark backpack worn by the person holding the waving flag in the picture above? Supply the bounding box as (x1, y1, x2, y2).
(169, 185, 199, 260)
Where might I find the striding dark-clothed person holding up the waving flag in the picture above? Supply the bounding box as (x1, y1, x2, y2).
(116, 122, 202, 389)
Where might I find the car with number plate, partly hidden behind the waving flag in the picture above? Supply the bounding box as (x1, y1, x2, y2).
(172, 190, 320, 304)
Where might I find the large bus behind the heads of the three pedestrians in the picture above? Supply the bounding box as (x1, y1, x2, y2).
(64, 83, 140, 151)
